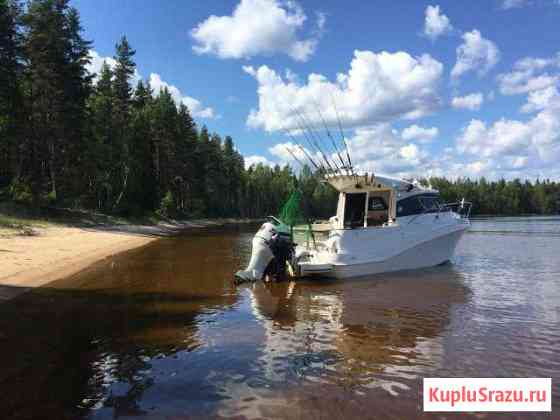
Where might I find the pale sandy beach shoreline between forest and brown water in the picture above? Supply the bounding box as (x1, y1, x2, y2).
(0, 219, 255, 302)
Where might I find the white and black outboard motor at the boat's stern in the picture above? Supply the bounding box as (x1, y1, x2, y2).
(235, 217, 294, 282)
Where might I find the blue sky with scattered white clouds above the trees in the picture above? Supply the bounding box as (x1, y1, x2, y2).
(73, 0, 560, 180)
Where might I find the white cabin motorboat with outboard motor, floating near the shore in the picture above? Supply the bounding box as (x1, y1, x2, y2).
(236, 172, 472, 281)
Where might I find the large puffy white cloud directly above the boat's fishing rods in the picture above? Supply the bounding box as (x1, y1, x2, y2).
(243, 51, 443, 131)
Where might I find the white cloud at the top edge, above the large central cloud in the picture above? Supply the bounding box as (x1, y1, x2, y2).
(191, 0, 325, 61)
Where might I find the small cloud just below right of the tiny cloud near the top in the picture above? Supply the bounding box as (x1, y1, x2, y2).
(451, 29, 500, 78)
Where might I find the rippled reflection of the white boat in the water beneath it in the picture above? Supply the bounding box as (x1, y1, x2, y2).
(247, 266, 471, 394)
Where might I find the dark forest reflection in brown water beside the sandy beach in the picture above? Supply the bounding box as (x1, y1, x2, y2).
(0, 233, 247, 419)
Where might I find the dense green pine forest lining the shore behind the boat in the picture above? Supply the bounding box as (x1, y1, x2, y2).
(0, 0, 560, 218)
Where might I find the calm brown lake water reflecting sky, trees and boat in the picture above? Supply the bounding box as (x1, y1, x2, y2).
(0, 217, 560, 419)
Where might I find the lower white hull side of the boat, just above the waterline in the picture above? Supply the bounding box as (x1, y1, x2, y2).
(300, 229, 466, 278)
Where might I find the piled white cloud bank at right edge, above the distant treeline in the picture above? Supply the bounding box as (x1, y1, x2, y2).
(448, 50, 560, 178)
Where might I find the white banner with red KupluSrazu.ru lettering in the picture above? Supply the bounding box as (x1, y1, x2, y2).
(424, 378, 552, 412)
